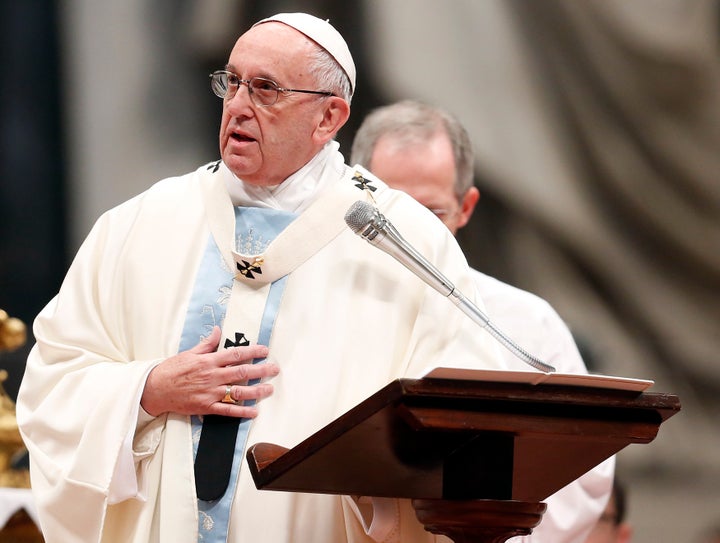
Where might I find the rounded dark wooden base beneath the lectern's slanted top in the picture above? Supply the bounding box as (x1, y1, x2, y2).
(412, 500, 546, 543)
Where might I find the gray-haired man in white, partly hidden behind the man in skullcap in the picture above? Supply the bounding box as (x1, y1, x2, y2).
(350, 100, 614, 543)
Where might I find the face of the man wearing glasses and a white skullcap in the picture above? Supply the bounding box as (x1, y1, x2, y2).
(220, 22, 326, 186)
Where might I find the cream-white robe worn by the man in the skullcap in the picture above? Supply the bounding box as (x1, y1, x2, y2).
(17, 157, 503, 543)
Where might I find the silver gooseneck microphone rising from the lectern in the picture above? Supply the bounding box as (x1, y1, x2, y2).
(345, 201, 555, 372)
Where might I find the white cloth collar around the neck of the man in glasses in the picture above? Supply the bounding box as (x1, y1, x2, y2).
(225, 140, 345, 213)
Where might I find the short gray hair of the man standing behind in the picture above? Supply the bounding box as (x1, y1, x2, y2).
(350, 100, 474, 199)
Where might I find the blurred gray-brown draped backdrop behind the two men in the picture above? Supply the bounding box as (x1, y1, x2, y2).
(0, 0, 720, 543)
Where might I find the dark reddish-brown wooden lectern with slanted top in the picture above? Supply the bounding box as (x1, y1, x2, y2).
(247, 370, 680, 543)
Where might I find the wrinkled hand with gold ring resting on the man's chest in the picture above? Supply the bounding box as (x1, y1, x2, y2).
(140, 326, 280, 418)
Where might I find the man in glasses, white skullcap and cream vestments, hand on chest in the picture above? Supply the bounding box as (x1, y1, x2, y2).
(17, 14, 504, 543)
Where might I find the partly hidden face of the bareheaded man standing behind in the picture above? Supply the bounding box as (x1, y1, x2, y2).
(368, 132, 472, 234)
